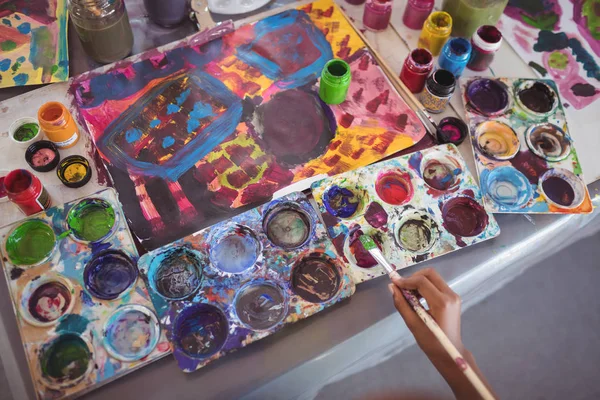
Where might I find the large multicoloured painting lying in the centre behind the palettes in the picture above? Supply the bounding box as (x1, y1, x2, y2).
(70, 0, 425, 249)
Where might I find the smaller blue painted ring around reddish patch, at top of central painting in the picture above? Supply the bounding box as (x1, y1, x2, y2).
(237, 10, 333, 89)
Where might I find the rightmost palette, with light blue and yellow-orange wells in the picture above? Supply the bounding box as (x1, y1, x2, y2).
(461, 77, 592, 214)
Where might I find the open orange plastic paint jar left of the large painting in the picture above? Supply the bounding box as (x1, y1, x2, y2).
(38, 101, 79, 149)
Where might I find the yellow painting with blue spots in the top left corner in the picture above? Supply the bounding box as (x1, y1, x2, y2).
(0, 0, 69, 88)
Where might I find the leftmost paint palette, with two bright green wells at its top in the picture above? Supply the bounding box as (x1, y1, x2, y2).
(0, 189, 170, 399)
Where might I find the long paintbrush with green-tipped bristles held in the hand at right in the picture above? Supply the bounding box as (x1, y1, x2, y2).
(360, 235, 495, 400)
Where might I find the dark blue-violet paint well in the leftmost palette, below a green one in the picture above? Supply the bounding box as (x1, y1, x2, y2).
(83, 250, 138, 300)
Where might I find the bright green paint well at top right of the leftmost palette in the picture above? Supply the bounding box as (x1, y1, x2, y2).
(67, 199, 116, 242)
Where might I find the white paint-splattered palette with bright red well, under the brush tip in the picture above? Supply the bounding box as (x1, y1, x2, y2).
(312, 144, 500, 283)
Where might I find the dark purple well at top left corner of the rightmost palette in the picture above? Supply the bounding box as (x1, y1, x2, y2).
(466, 78, 510, 117)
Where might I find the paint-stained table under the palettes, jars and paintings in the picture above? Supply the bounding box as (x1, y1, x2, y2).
(0, 0, 600, 399)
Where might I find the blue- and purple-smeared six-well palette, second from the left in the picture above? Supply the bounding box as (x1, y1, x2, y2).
(138, 192, 354, 372)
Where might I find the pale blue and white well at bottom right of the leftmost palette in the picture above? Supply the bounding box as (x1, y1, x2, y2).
(103, 304, 160, 362)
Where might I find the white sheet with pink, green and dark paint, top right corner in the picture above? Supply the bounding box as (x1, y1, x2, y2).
(499, 0, 600, 181)
